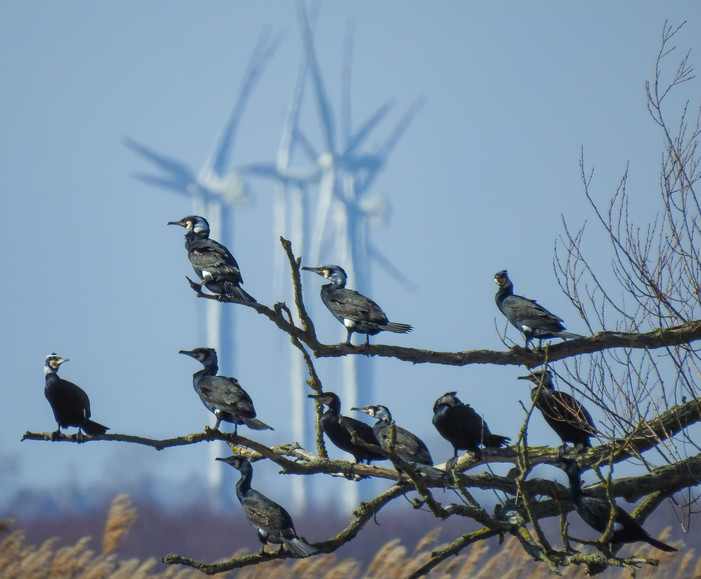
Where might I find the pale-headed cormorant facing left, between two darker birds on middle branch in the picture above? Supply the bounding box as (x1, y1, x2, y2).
(351, 405, 445, 480)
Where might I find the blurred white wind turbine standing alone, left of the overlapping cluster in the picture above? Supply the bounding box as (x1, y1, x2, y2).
(124, 35, 279, 508)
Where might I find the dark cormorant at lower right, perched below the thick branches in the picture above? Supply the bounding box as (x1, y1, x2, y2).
(556, 459, 677, 551)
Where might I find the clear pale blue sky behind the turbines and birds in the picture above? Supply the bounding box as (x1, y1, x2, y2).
(0, 0, 701, 516)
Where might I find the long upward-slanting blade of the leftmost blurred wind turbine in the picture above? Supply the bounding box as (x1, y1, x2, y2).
(202, 32, 280, 177)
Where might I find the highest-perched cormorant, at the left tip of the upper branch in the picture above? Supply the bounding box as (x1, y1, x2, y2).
(168, 215, 256, 303)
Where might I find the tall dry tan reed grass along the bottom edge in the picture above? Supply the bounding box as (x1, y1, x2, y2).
(0, 495, 701, 579)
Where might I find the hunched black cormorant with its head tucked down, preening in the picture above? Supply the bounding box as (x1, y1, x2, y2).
(433, 392, 511, 459)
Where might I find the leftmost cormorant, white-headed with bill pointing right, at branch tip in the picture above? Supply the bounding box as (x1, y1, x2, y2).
(44, 354, 109, 439)
